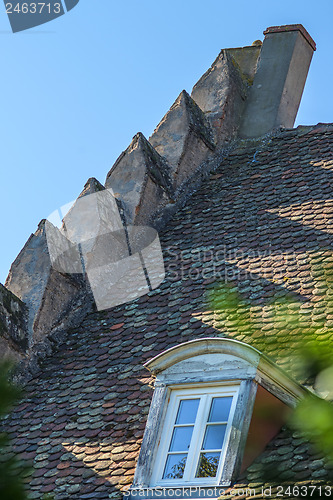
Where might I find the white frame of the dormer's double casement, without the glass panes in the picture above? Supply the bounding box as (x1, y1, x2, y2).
(151, 384, 239, 486)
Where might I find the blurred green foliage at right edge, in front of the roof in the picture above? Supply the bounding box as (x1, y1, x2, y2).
(211, 279, 333, 463)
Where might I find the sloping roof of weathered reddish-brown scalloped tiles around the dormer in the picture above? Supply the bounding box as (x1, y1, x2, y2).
(2, 124, 333, 500)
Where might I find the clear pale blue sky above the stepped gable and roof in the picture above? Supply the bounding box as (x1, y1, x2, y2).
(0, 0, 333, 283)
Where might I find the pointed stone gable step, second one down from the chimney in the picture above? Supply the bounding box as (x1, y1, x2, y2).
(149, 90, 215, 189)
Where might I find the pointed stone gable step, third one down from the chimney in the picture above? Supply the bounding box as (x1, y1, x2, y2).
(105, 133, 173, 225)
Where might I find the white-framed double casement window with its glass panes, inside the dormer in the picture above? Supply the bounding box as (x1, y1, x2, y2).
(152, 385, 239, 486)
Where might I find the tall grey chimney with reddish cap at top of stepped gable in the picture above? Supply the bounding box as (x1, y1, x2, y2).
(240, 24, 316, 138)
